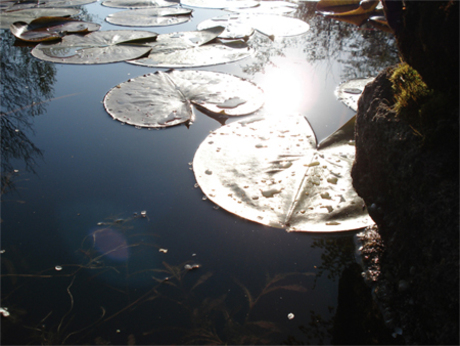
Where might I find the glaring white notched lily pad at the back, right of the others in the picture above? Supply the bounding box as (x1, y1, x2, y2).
(197, 14, 310, 39)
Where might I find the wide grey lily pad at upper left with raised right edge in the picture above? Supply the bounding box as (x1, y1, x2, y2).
(31, 30, 157, 64)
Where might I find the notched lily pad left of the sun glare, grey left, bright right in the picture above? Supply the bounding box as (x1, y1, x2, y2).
(104, 70, 263, 127)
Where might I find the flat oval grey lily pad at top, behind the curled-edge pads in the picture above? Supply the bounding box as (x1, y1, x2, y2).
(105, 7, 192, 26)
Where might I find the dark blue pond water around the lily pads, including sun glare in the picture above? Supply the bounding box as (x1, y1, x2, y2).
(0, 2, 398, 344)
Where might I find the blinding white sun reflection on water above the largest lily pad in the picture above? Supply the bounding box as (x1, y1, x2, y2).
(257, 59, 319, 114)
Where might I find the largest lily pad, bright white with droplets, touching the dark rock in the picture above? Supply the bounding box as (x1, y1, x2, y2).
(193, 115, 372, 232)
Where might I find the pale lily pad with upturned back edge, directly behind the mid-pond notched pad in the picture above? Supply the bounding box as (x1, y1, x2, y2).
(128, 27, 254, 68)
